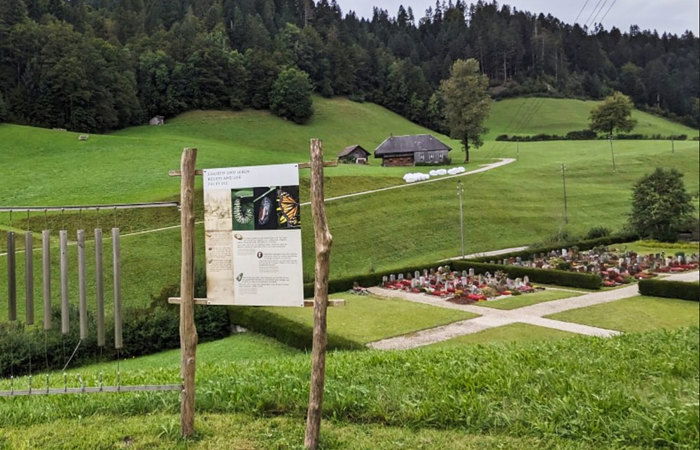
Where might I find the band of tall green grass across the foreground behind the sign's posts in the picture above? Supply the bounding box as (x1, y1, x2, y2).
(0, 327, 700, 448)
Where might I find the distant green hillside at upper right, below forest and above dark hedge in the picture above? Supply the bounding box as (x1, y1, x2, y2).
(486, 97, 698, 139)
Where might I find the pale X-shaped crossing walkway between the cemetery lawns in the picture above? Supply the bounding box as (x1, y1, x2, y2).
(367, 271, 698, 350)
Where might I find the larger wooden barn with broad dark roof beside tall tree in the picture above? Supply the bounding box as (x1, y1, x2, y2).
(374, 134, 452, 166)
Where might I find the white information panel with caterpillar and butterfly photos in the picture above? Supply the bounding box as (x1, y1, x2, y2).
(203, 164, 304, 306)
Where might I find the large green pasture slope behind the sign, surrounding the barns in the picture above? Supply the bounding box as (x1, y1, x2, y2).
(0, 98, 699, 316)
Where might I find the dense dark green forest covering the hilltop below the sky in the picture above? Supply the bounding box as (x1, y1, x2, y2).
(0, 0, 700, 131)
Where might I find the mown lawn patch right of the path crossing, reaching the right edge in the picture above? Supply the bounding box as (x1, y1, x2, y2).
(548, 295, 700, 332)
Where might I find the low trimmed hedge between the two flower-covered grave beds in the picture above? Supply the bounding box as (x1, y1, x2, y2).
(452, 260, 602, 289)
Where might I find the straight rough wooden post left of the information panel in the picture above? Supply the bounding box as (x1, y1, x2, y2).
(180, 148, 197, 437)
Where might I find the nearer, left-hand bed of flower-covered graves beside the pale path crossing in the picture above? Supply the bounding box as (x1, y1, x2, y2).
(382, 266, 544, 304)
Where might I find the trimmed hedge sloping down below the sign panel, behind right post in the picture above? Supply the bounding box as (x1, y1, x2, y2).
(229, 306, 365, 350)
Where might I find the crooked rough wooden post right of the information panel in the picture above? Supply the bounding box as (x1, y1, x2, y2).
(304, 139, 333, 450)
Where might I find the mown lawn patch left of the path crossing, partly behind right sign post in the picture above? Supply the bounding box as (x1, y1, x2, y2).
(249, 293, 478, 344)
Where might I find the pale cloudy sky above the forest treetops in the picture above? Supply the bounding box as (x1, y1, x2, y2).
(336, 0, 700, 36)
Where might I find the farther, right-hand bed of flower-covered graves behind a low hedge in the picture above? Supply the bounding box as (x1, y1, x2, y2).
(498, 247, 698, 287)
